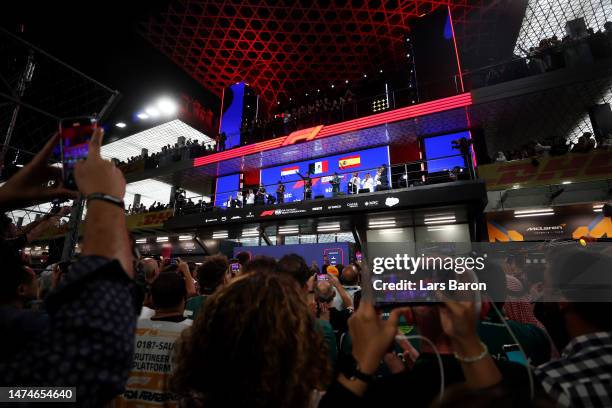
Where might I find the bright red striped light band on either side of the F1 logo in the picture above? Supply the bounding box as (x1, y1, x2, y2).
(193, 92, 472, 167)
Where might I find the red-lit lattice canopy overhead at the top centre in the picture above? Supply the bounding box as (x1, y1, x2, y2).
(142, 0, 487, 102)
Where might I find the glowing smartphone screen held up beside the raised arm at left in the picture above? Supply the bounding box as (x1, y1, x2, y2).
(59, 118, 97, 190)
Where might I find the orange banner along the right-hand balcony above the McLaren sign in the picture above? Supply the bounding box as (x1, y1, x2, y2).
(478, 150, 612, 190)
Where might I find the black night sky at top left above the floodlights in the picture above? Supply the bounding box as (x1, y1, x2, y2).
(0, 0, 220, 120)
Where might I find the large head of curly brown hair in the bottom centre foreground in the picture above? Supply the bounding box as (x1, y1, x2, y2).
(171, 273, 331, 408)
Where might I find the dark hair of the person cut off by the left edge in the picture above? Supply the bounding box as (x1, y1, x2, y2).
(0, 240, 33, 304)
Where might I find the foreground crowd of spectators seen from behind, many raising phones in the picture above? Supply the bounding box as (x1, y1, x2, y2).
(0, 130, 612, 408)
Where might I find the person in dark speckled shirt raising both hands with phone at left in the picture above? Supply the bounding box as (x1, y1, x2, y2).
(0, 129, 140, 407)
